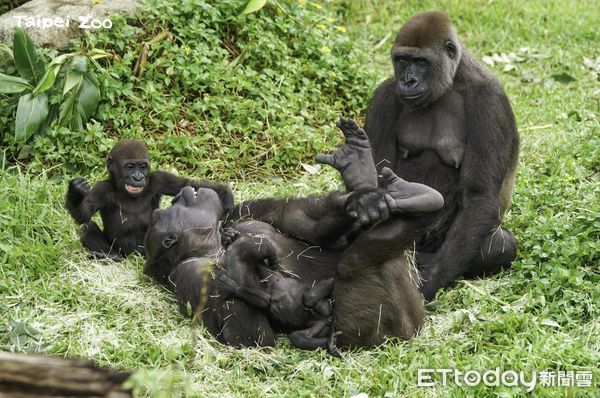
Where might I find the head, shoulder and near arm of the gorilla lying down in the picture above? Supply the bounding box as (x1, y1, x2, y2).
(144, 187, 275, 347)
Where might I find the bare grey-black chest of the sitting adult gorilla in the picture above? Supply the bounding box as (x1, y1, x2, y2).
(395, 94, 465, 169)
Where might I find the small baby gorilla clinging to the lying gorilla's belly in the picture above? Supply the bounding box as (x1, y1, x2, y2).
(219, 228, 340, 356)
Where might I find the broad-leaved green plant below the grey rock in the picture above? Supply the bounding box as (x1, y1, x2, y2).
(0, 28, 110, 149)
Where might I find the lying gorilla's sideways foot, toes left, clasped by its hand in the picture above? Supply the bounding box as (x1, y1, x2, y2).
(381, 167, 444, 213)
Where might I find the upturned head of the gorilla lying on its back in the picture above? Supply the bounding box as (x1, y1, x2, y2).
(145, 187, 223, 266)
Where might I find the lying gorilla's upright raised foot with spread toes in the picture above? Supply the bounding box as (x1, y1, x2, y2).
(316, 118, 377, 192)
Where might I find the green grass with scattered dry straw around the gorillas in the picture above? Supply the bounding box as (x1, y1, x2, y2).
(0, 0, 600, 397)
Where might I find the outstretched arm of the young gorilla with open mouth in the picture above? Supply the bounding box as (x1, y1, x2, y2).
(150, 171, 233, 213)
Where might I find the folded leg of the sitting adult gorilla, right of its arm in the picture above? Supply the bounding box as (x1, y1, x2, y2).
(465, 226, 518, 278)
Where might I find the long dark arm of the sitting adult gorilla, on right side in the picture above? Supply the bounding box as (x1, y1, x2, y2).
(417, 87, 519, 300)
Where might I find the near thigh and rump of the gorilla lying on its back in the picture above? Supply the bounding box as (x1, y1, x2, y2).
(332, 215, 431, 347)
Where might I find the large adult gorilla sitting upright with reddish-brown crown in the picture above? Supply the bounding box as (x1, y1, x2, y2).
(365, 12, 519, 300)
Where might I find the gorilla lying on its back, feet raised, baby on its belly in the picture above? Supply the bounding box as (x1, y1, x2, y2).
(145, 119, 443, 354)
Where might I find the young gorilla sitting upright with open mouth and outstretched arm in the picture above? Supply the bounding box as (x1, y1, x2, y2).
(65, 140, 233, 258)
